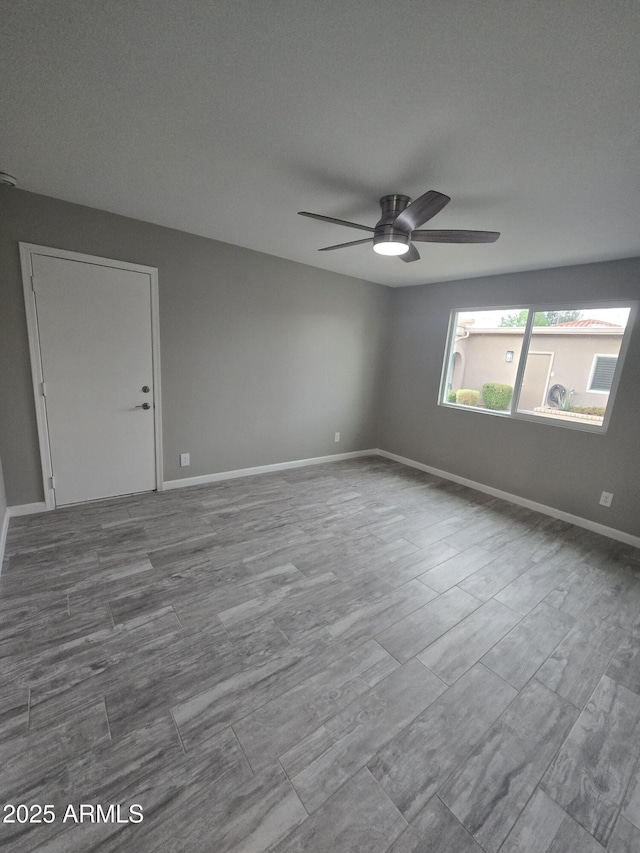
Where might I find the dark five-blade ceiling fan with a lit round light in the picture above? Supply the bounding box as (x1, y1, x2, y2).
(298, 190, 500, 263)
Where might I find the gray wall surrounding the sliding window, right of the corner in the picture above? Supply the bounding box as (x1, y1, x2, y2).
(378, 258, 640, 536)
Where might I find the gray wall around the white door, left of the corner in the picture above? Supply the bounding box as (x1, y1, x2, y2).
(0, 189, 392, 505)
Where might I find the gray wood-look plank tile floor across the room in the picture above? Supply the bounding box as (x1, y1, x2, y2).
(0, 457, 640, 853)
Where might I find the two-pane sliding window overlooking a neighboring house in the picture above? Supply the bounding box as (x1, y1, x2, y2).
(439, 303, 636, 431)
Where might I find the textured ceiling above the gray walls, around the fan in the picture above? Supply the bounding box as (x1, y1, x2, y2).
(0, 0, 640, 286)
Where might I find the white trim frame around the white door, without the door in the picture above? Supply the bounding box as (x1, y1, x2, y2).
(18, 242, 163, 509)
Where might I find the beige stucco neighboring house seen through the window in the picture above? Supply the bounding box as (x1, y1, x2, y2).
(451, 319, 624, 411)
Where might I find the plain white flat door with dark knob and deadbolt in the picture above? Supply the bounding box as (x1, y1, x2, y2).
(31, 254, 156, 506)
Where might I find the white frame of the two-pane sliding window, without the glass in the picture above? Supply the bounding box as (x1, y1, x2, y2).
(438, 299, 638, 435)
